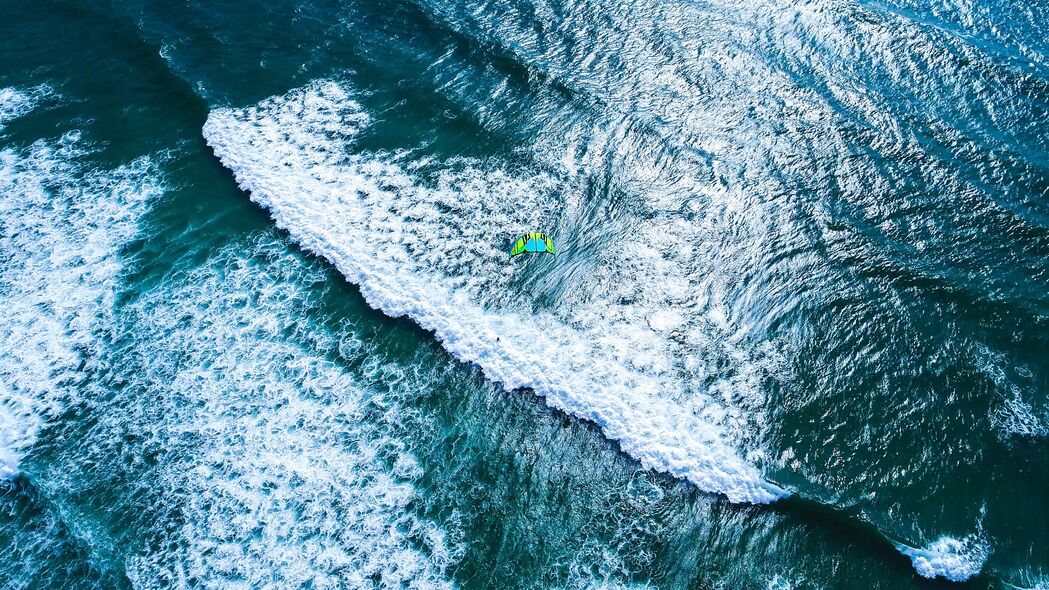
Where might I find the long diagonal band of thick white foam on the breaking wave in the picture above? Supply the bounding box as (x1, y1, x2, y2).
(204, 82, 787, 503)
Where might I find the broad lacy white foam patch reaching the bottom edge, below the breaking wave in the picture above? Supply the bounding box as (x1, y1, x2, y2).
(112, 239, 463, 589)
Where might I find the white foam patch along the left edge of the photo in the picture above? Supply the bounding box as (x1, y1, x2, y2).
(0, 122, 160, 479)
